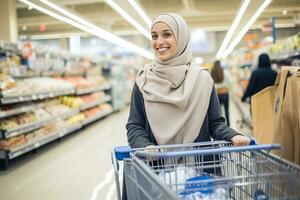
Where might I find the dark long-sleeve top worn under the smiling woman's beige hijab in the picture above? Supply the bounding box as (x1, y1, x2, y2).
(126, 84, 239, 148)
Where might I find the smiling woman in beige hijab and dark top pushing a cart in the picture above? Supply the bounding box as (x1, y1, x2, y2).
(123, 13, 249, 199)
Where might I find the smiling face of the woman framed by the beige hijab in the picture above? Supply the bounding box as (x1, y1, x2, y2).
(151, 22, 176, 61)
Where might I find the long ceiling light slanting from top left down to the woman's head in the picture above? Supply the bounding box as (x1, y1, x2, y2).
(19, 0, 154, 60)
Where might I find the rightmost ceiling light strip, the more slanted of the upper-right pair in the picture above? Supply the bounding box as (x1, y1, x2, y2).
(222, 0, 272, 59)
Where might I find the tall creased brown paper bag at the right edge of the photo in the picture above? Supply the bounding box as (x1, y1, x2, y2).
(273, 67, 299, 162)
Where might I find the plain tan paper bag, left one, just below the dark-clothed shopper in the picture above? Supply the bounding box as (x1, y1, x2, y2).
(251, 86, 275, 144)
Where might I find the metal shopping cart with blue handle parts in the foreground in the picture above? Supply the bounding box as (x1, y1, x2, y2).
(112, 141, 300, 200)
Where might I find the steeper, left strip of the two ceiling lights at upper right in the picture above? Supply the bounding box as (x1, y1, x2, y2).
(216, 0, 251, 59)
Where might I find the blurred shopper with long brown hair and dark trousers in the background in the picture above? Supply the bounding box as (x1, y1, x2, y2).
(210, 60, 231, 126)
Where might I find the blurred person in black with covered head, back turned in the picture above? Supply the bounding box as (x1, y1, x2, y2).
(242, 53, 277, 102)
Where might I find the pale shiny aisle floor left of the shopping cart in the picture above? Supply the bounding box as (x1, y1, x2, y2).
(0, 109, 128, 200)
